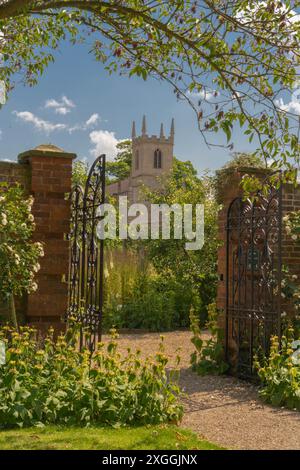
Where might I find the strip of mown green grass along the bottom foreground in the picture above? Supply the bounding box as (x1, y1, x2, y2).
(0, 425, 220, 450)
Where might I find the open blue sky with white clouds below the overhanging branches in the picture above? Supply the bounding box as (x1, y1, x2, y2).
(0, 40, 258, 172)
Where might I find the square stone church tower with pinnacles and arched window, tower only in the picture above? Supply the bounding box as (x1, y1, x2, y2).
(131, 116, 175, 182)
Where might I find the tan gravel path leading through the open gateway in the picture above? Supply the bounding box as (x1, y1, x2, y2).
(104, 331, 300, 450)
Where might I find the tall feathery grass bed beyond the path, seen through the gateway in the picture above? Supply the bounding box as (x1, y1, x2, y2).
(104, 248, 192, 331)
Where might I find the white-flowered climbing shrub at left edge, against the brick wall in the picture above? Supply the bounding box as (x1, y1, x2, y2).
(0, 183, 44, 323)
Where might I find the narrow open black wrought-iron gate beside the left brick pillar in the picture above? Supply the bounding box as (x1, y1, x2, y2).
(67, 155, 105, 350)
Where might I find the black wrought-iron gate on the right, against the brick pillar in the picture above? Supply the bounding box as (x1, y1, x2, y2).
(226, 182, 282, 378)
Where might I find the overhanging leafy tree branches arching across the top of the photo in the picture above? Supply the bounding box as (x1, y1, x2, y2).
(0, 0, 300, 176)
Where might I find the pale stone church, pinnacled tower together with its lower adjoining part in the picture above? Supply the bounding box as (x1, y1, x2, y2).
(107, 116, 175, 203)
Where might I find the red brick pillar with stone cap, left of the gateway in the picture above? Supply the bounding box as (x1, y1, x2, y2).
(18, 145, 76, 330)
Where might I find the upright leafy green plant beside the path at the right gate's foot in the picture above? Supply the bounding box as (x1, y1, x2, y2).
(190, 304, 228, 375)
